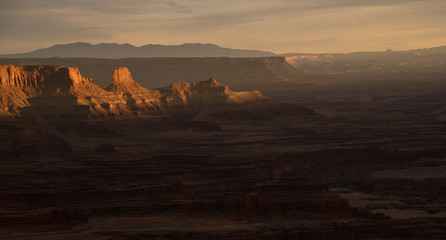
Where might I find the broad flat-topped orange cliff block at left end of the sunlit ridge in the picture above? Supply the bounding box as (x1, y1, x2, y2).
(0, 65, 105, 115)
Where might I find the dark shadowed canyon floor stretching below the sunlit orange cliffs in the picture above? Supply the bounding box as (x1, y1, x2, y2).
(0, 67, 446, 240)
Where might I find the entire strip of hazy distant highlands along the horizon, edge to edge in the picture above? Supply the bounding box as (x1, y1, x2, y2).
(0, 42, 446, 59)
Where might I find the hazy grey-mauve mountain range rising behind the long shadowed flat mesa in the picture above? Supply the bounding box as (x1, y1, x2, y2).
(0, 42, 276, 58)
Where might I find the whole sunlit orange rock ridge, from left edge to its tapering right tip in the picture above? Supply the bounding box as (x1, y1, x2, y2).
(0, 65, 265, 116)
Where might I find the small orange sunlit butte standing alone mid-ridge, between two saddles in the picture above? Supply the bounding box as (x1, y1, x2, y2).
(105, 67, 149, 93)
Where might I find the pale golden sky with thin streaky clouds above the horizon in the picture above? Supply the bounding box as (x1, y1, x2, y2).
(0, 0, 446, 54)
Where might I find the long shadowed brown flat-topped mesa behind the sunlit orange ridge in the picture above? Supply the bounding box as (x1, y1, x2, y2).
(0, 57, 304, 94)
